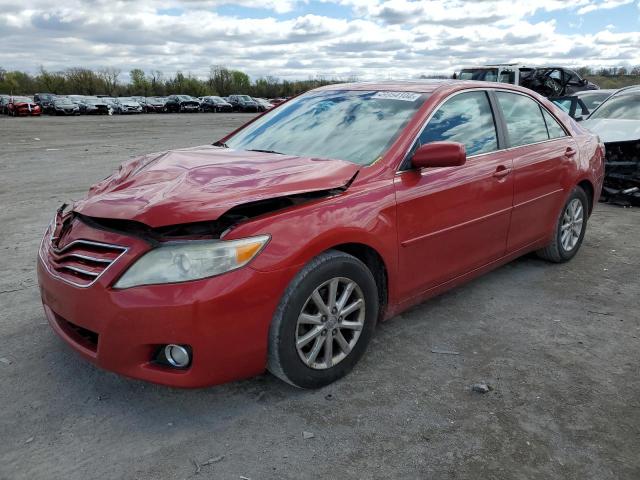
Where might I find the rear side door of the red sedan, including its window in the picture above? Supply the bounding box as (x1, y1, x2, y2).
(495, 91, 577, 252)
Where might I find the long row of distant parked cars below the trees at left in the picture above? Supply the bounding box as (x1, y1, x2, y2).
(0, 93, 285, 116)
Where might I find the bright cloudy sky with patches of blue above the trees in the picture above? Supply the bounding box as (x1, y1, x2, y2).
(0, 0, 640, 79)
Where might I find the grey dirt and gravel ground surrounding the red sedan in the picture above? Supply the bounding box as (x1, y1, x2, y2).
(0, 114, 640, 480)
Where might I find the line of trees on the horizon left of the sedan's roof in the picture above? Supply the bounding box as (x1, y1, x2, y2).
(0, 66, 356, 98)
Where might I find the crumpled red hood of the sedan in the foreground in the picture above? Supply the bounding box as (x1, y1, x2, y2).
(73, 146, 360, 227)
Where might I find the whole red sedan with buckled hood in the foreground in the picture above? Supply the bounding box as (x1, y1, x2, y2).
(38, 81, 604, 388)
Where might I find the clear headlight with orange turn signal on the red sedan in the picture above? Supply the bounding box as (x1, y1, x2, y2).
(114, 235, 269, 288)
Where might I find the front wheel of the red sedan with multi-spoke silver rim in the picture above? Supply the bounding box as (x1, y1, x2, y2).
(267, 250, 379, 388)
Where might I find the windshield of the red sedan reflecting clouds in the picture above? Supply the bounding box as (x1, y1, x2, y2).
(227, 90, 427, 165)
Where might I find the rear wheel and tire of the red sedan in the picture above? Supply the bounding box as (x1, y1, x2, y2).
(536, 187, 589, 263)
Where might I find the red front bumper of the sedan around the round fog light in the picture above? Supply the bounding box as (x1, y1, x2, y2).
(38, 221, 296, 387)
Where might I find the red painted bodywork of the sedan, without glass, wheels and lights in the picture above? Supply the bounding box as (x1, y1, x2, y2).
(38, 82, 604, 387)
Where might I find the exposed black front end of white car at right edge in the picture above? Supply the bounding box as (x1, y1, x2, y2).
(600, 139, 640, 206)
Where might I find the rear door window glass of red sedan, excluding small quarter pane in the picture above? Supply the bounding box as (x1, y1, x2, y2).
(496, 92, 549, 147)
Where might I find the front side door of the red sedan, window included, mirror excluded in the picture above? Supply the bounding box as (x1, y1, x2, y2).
(395, 90, 513, 298)
